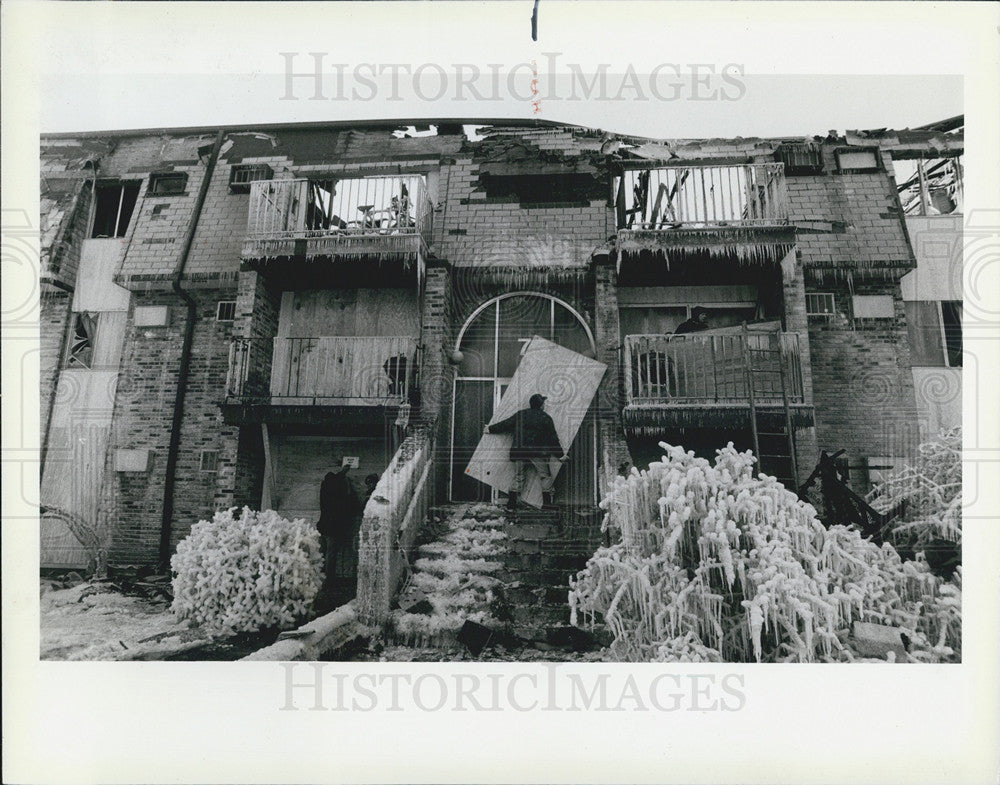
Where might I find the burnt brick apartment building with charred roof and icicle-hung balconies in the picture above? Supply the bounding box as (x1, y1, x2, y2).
(41, 118, 962, 624)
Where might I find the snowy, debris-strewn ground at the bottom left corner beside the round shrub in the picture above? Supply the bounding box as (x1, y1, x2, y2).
(40, 583, 209, 660)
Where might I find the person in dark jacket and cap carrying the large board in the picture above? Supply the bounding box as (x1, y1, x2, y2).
(483, 393, 569, 512)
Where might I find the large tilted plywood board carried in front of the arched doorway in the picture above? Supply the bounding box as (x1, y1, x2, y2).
(465, 335, 607, 507)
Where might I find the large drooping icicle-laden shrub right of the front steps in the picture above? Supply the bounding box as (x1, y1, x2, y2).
(570, 443, 960, 662)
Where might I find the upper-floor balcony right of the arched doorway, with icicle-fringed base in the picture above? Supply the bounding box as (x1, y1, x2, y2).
(615, 163, 794, 269)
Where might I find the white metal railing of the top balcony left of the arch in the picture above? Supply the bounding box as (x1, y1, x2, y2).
(247, 175, 432, 240)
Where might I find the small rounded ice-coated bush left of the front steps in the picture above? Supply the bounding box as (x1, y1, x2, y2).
(170, 507, 323, 635)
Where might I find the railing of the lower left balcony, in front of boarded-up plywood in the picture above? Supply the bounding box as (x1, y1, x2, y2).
(226, 336, 417, 406)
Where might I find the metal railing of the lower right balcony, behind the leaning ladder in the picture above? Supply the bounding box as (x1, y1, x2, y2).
(624, 332, 804, 405)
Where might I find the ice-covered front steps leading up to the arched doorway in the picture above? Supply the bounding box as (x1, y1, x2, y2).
(391, 504, 602, 647)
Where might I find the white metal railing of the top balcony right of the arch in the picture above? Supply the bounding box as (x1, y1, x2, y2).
(615, 163, 788, 231)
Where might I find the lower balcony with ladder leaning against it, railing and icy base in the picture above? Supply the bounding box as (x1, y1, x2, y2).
(624, 332, 812, 433)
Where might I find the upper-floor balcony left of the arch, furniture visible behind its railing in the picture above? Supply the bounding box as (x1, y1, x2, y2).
(242, 175, 432, 282)
